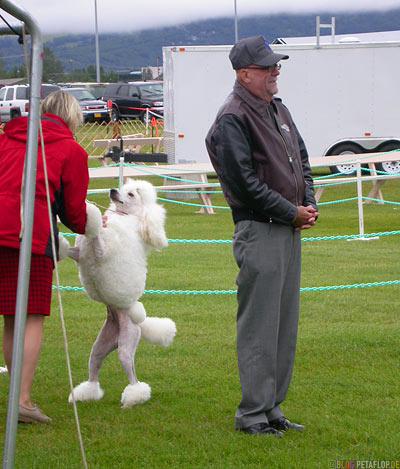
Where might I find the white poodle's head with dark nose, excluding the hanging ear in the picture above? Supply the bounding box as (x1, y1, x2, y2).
(110, 179, 157, 215)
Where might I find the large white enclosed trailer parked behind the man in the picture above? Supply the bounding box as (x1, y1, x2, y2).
(163, 31, 400, 173)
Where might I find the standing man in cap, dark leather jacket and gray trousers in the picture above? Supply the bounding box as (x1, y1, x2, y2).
(206, 36, 318, 436)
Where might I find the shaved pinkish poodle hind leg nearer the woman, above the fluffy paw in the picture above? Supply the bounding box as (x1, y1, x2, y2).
(89, 306, 119, 381)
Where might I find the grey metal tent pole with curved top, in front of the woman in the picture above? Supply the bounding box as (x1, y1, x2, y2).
(0, 0, 43, 469)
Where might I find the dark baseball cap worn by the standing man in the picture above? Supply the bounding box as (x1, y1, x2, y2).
(229, 36, 289, 70)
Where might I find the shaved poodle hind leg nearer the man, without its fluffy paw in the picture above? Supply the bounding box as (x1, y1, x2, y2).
(115, 310, 141, 384)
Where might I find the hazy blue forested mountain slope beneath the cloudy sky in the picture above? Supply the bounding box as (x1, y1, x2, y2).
(0, 8, 400, 72)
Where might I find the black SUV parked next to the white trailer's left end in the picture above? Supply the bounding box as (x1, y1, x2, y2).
(103, 81, 164, 122)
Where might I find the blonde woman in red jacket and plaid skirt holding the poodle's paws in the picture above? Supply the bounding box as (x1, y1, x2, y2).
(0, 91, 101, 423)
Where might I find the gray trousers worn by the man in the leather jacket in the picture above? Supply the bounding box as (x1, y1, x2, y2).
(233, 220, 301, 428)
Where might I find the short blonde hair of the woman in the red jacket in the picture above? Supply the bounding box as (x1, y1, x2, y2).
(40, 90, 83, 134)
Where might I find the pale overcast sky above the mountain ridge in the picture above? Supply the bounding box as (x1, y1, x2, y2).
(0, 0, 400, 34)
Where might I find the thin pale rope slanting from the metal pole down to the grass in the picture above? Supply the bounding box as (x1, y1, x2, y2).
(39, 121, 87, 469)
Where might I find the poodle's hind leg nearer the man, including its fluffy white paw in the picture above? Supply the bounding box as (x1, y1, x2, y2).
(117, 311, 151, 408)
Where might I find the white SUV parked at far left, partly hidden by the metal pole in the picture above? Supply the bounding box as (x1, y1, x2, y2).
(0, 84, 60, 122)
